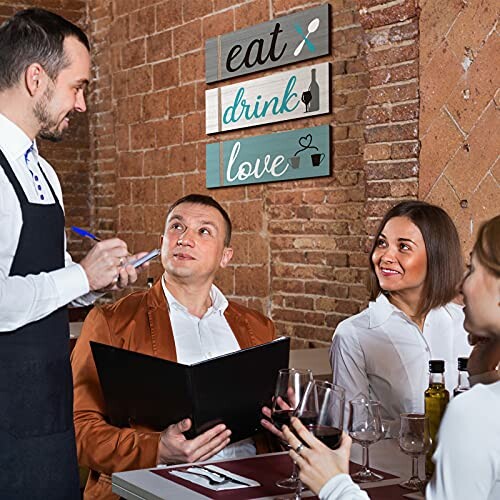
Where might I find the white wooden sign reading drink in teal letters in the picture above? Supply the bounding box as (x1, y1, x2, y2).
(205, 63, 330, 134)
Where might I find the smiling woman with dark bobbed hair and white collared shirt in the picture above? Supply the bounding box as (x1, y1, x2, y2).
(330, 200, 470, 432)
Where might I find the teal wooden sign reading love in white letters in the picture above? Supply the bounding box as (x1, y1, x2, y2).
(206, 125, 330, 188)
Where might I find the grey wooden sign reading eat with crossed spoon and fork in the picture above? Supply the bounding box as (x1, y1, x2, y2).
(205, 4, 330, 83)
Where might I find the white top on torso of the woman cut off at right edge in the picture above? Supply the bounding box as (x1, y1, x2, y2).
(425, 382, 500, 500)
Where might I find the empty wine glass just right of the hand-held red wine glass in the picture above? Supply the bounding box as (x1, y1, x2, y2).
(349, 398, 384, 483)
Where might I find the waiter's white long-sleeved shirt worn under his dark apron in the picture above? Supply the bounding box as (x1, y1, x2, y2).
(0, 113, 99, 332)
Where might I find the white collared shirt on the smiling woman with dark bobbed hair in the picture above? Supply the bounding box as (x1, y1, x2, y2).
(330, 294, 471, 435)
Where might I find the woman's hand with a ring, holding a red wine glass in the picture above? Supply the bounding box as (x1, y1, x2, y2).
(283, 417, 352, 495)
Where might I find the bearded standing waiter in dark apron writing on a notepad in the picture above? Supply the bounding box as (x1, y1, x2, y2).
(0, 9, 144, 500)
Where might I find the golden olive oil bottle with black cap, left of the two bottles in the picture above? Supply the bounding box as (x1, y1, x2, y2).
(424, 359, 450, 478)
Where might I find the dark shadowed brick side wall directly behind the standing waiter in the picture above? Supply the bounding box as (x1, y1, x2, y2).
(0, 0, 92, 260)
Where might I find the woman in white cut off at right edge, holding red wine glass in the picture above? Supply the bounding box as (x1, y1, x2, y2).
(283, 215, 500, 500)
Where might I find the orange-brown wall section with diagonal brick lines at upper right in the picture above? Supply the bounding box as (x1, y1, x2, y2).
(419, 0, 500, 255)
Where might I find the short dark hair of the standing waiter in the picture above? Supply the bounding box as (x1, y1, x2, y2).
(0, 9, 90, 91)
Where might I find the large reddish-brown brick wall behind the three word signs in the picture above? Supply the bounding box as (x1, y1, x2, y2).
(83, 0, 430, 346)
